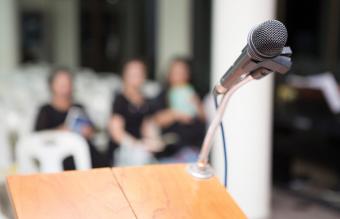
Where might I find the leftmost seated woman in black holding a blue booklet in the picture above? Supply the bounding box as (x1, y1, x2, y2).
(35, 68, 109, 170)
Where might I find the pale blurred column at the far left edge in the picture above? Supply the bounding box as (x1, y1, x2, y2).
(0, 0, 19, 73)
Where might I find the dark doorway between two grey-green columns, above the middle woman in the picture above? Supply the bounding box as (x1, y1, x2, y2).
(81, 0, 156, 78)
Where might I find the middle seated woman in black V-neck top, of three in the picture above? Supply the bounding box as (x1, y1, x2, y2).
(109, 59, 162, 165)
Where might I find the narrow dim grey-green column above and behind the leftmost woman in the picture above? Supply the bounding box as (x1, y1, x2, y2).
(50, 0, 80, 68)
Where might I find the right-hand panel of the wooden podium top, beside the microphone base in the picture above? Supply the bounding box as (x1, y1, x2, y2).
(112, 165, 246, 219)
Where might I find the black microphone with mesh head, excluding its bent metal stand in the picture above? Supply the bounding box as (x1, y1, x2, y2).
(214, 20, 292, 94)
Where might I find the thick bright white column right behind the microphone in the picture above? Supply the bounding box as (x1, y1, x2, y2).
(211, 0, 275, 219)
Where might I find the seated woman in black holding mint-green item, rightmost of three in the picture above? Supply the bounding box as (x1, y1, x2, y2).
(154, 58, 205, 162)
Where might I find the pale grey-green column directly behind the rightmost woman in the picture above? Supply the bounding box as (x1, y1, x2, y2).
(156, 0, 192, 79)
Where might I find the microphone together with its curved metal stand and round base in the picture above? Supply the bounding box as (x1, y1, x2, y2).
(188, 20, 292, 179)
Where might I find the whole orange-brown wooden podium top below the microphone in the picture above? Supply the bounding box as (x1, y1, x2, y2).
(7, 164, 246, 219)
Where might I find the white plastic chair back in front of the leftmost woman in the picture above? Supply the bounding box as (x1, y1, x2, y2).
(16, 131, 91, 173)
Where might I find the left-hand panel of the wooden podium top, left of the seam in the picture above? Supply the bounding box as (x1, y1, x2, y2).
(7, 168, 136, 219)
